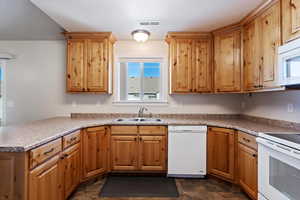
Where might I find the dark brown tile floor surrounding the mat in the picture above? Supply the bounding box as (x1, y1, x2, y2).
(69, 178, 249, 200)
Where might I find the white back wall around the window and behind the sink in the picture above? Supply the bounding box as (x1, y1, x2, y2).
(0, 41, 241, 124)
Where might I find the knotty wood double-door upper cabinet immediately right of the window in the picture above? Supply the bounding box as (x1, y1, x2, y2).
(166, 32, 212, 93)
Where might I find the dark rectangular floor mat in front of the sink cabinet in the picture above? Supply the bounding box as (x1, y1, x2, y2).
(100, 176, 179, 197)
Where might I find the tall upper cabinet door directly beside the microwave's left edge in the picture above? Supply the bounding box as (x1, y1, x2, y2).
(259, 2, 281, 88)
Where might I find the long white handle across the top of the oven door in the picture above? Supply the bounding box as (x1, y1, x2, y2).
(256, 137, 300, 159)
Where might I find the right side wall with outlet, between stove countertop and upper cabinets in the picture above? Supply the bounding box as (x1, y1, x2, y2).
(242, 91, 300, 123)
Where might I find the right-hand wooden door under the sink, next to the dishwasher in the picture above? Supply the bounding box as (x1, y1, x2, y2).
(139, 136, 166, 171)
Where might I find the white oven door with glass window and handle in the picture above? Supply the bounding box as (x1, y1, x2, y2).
(257, 138, 300, 200)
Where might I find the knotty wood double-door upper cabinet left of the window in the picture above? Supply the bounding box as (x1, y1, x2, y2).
(65, 33, 115, 93)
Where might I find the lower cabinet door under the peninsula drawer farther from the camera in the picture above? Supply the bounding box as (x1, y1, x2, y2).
(63, 144, 81, 199)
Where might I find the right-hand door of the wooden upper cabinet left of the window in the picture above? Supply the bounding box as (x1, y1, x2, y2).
(87, 39, 108, 92)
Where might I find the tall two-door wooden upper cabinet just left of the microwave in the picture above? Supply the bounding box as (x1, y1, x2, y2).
(243, 1, 281, 91)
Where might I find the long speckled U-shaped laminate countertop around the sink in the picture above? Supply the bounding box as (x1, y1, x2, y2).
(0, 117, 297, 152)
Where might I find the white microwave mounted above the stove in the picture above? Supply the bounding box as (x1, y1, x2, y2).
(278, 39, 300, 87)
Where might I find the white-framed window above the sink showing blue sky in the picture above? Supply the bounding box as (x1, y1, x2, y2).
(119, 59, 163, 102)
